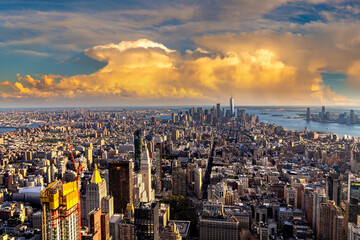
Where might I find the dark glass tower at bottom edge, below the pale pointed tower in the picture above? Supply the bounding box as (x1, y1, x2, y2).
(135, 202, 159, 240)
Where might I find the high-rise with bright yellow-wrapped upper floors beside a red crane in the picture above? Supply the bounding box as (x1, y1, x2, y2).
(40, 181, 81, 240)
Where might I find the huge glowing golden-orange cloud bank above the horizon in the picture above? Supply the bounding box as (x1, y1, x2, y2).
(2, 36, 353, 104)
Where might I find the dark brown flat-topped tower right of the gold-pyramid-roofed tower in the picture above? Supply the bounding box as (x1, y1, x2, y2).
(109, 159, 133, 213)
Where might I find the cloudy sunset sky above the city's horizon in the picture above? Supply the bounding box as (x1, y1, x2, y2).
(0, 0, 360, 107)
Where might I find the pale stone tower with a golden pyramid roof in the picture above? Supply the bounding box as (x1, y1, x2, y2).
(82, 165, 107, 225)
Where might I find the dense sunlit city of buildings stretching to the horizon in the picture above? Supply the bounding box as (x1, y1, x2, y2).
(0, 98, 360, 240)
